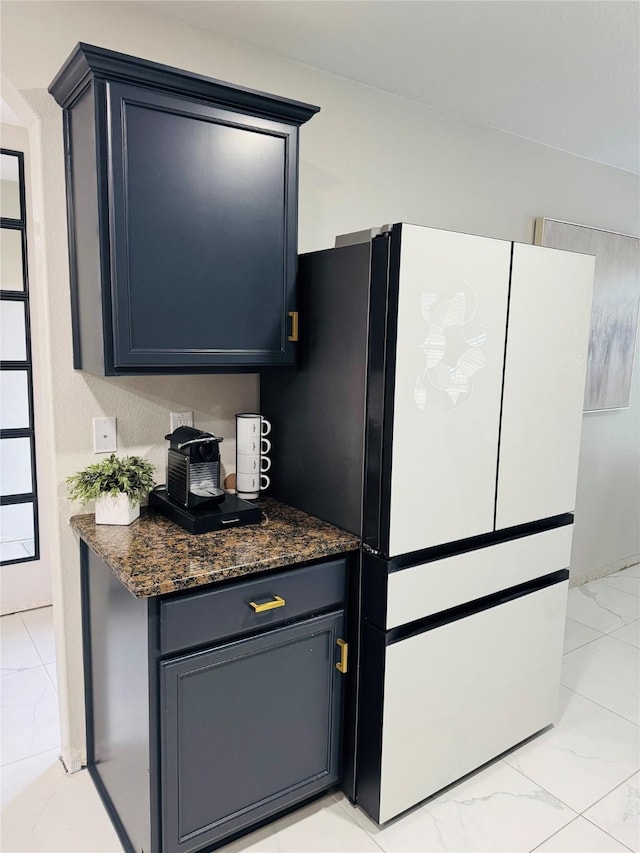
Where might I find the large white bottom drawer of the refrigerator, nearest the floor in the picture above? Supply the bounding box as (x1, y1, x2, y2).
(358, 581, 568, 823)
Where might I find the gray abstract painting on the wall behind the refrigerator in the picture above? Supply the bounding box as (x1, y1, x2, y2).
(534, 219, 640, 412)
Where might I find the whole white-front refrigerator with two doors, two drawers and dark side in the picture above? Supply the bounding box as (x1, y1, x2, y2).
(261, 224, 594, 823)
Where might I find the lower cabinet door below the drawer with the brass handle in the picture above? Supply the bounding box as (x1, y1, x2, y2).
(160, 611, 344, 853)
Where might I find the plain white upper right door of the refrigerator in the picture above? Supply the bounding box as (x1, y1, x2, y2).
(496, 244, 594, 529)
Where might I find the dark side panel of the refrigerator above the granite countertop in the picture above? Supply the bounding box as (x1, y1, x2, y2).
(260, 243, 371, 535)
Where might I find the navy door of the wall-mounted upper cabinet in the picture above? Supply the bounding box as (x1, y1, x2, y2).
(109, 84, 295, 367)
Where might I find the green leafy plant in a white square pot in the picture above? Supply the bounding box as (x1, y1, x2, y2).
(67, 453, 154, 524)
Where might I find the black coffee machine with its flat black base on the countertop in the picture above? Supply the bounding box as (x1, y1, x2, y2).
(149, 427, 262, 533)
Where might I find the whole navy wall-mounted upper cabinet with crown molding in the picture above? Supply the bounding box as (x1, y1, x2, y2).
(49, 44, 318, 376)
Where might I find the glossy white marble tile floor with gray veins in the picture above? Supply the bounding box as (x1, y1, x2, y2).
(0, 566, 640, 853)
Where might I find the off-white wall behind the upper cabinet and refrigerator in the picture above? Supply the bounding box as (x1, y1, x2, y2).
(2, 2, 640, 750)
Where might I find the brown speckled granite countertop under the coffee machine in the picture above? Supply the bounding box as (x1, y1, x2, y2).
(70, 498, 360, 598)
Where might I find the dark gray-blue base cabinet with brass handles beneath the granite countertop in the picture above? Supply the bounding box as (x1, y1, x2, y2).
(82, 543, 350, 853)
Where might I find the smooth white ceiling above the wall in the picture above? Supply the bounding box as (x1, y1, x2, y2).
(136, 0, 640, 173)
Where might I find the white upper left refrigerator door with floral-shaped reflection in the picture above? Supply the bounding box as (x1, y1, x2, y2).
(389, 225, 511, 556)
